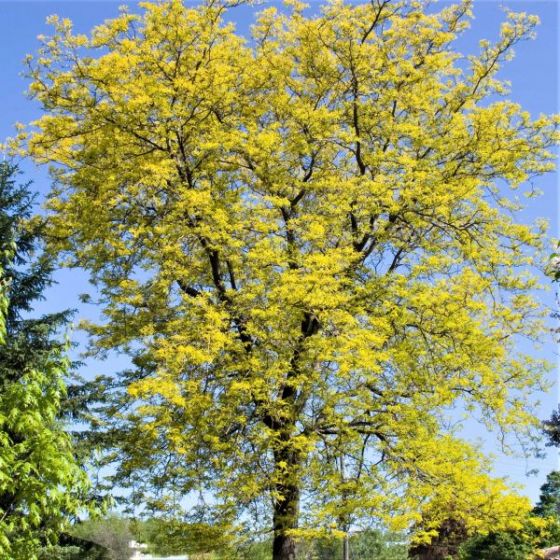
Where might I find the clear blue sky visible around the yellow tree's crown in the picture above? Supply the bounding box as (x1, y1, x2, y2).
(0, 0, 560, 506)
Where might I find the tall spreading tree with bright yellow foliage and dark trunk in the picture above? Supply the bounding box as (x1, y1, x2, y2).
(22, 0, 558, 560)
